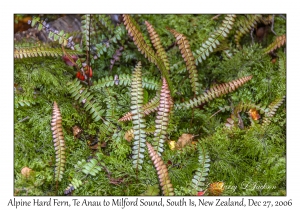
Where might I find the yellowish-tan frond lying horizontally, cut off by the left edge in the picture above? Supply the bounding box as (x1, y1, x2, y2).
(14, 46, 82, 59)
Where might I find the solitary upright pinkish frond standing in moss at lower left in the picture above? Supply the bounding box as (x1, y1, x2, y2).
(51, 101, 66, 182)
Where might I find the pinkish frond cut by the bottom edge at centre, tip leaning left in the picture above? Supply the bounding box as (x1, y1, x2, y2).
(146, 142, 175, 196)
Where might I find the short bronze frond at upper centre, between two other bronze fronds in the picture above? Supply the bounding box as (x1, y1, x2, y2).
(145, 21, 170, 72)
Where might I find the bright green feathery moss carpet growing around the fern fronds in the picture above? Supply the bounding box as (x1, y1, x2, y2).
(14, 15, 286, 196)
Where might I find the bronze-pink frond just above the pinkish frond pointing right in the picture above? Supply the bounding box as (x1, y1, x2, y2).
(170, 29, 200, 95)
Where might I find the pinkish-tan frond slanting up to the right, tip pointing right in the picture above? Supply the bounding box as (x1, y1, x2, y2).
(175, 76, 252, 109)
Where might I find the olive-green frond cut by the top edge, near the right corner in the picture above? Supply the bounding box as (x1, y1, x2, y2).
(234, 14, 263, 48)
